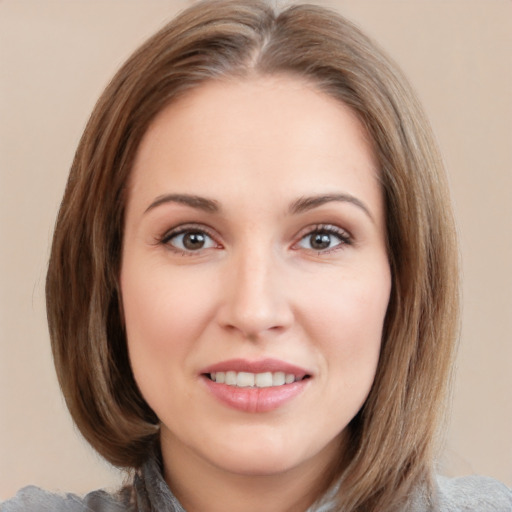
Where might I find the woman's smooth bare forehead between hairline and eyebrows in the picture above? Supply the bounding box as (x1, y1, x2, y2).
(130, 76, 378, 212)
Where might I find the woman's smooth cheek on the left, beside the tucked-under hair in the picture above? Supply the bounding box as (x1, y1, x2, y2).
(121, 260, 222, 419)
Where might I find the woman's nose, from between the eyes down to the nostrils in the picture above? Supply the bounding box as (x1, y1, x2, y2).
(219, 245, 293, 340)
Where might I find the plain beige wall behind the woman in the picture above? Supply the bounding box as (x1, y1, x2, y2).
(0, 0, 512, 498)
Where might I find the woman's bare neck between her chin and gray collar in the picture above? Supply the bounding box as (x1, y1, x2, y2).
(162, 432, 340, 512)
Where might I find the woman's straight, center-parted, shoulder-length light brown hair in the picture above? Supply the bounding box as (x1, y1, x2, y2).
(46, 0, 458, 511)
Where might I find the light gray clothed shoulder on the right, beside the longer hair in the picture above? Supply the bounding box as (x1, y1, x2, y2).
(437, 476, 512, 512)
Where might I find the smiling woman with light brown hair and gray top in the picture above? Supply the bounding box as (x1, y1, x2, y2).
(2, 1, 512, 512)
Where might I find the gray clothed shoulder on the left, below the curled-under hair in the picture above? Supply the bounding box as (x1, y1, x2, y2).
(0, 486, 131, 512)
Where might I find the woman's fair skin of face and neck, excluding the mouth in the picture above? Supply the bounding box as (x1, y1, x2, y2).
(121, 76, 391, 512)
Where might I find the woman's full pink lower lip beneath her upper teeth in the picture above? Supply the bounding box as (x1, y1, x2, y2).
(203, 376, 311, 413)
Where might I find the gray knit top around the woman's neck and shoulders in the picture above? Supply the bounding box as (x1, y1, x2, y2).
(0, 458, 512, 512)
